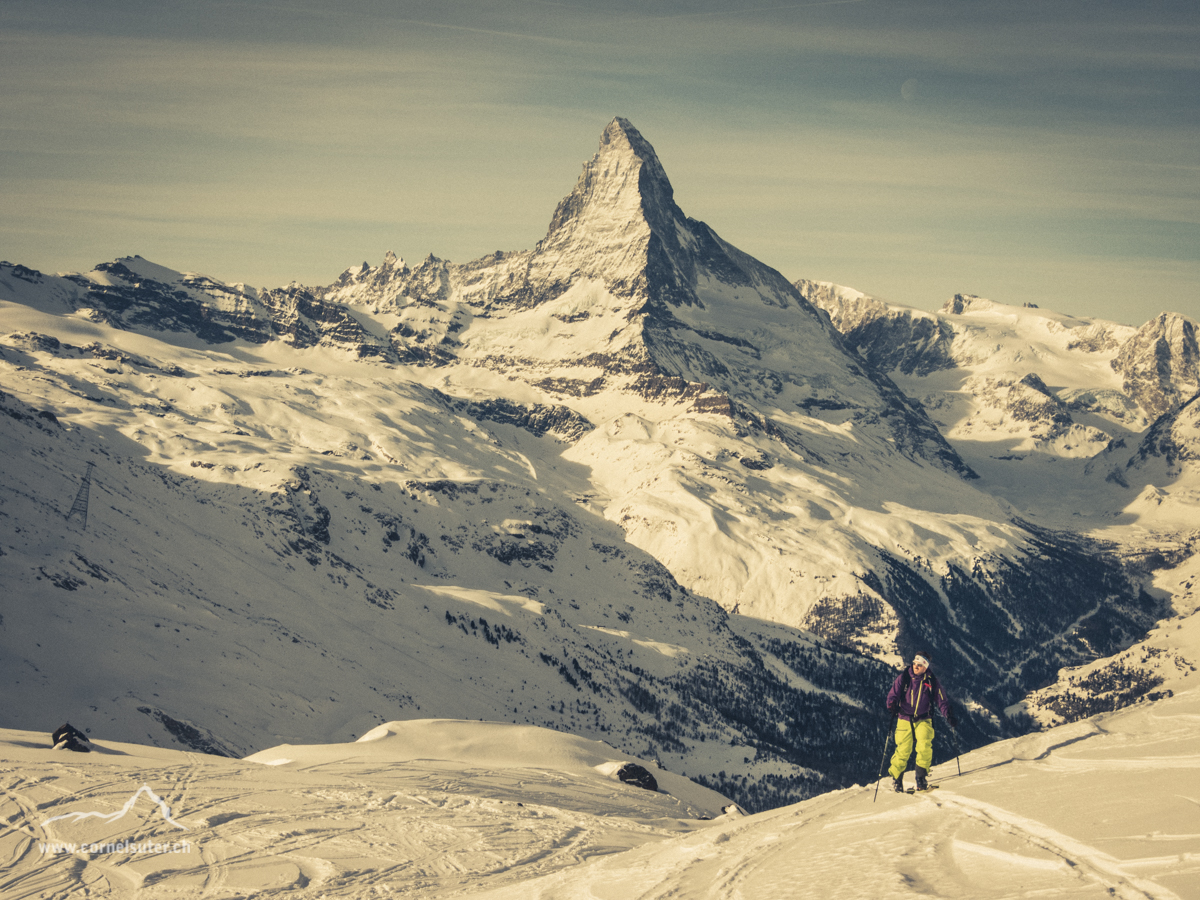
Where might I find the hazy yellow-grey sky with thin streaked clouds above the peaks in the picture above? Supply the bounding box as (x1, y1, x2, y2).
(0, 0, 1200, 325)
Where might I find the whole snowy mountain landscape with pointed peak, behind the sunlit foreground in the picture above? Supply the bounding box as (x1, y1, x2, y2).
(0, 119, 1200, 809)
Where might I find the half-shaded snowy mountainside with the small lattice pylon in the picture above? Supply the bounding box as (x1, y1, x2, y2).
(0, 292, 902, 804)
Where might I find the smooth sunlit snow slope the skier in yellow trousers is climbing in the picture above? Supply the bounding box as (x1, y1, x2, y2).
(478, 691, 1200, 900)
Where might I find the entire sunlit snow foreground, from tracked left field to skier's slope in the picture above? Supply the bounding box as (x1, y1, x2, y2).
(0, 690, 1200, 900)
